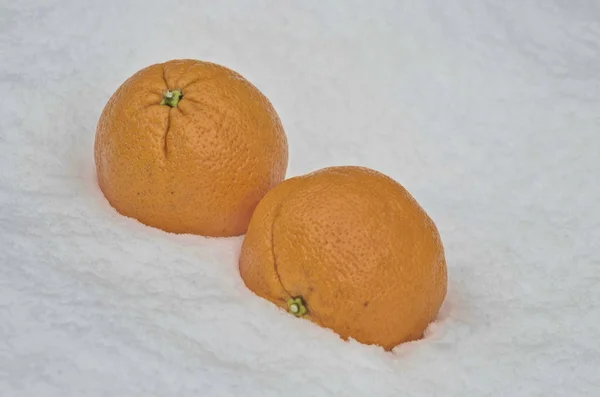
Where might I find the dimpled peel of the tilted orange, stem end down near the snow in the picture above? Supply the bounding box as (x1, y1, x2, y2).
(239, 166, 447, 350)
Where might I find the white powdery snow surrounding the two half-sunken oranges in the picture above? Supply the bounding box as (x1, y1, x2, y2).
(0, 0, 600, 397)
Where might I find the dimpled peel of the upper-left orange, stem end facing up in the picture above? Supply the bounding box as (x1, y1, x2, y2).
(94, 60, 288, 237)
